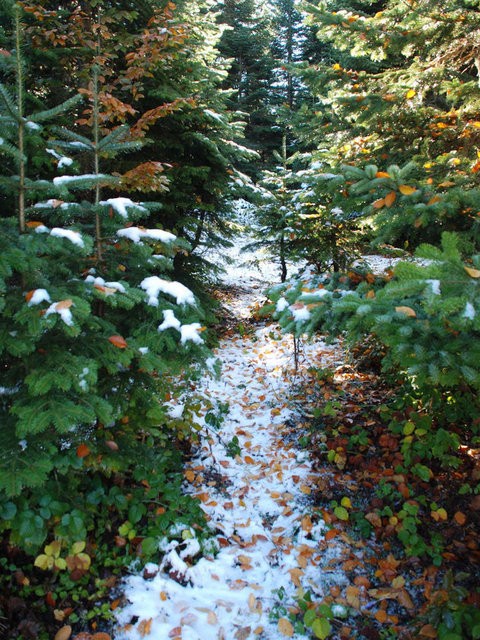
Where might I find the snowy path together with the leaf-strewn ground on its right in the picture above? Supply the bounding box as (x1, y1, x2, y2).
(115, 228, 480, 640)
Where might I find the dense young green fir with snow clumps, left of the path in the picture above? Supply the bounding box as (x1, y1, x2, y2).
(0, 6, 208, 510)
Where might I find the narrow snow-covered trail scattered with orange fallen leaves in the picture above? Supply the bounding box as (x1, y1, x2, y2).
(115, 246, 346, 640)
